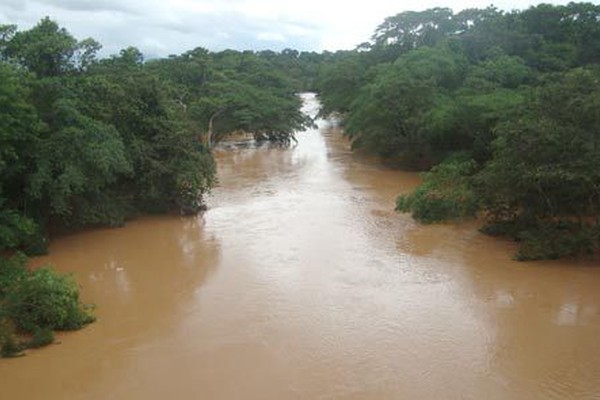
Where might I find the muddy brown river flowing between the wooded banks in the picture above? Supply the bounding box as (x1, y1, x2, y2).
(0, 95, 600, 400)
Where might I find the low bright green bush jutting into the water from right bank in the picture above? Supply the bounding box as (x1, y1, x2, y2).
(396, 161, 477, 223)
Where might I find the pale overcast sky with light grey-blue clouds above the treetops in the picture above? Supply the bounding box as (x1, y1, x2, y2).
(0, 0, 580, 57)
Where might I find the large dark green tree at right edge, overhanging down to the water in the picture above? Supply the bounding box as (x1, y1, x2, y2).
(476, 68, 600, 259)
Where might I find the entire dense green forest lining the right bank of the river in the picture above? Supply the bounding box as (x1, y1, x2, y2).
(318, 3, 600, 260)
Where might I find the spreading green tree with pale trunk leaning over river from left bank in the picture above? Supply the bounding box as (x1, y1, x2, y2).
(150, 49, 311, 147)
